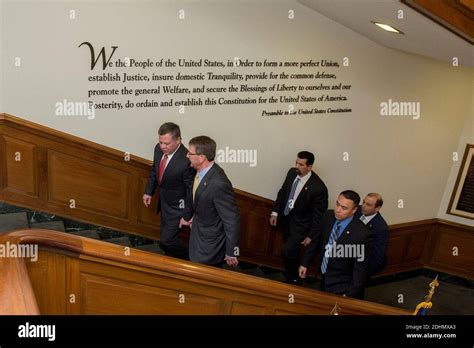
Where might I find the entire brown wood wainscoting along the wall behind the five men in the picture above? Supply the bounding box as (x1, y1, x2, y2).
(0, 114, 474, 279)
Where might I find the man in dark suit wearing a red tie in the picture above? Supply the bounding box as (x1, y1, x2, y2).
(143, 122, 196, 259)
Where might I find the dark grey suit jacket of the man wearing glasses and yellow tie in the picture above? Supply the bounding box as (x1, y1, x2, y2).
(189, 163, 240, 265)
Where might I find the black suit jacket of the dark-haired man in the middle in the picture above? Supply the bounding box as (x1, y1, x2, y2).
(273, 168, 328, 239)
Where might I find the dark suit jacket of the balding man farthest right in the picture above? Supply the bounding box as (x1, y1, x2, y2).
(354, 207, 388, 276)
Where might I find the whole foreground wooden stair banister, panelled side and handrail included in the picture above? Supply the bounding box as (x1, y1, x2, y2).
(0, 230, 410, 315)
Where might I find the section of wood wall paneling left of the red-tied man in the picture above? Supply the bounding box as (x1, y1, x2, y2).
(0, 114, 159, 239)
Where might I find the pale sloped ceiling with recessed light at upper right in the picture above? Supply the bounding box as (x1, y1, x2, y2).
(298, 0, 474, 67)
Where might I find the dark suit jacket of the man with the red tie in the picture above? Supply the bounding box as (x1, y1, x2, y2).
(145, 144, 196, 223)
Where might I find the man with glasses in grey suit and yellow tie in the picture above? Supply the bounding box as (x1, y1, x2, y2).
(182, 136, 240, 267)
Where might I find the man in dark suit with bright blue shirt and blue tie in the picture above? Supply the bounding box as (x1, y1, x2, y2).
(299, 190, 373, 298)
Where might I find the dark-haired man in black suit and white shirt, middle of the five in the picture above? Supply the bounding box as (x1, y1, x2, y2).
(270, 151, 328, 284)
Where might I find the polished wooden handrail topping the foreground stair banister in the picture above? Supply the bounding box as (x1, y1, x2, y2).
(0, 229, 410, 315)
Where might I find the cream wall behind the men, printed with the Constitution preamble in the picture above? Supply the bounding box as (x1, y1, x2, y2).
(2, 0, 473, 224)
